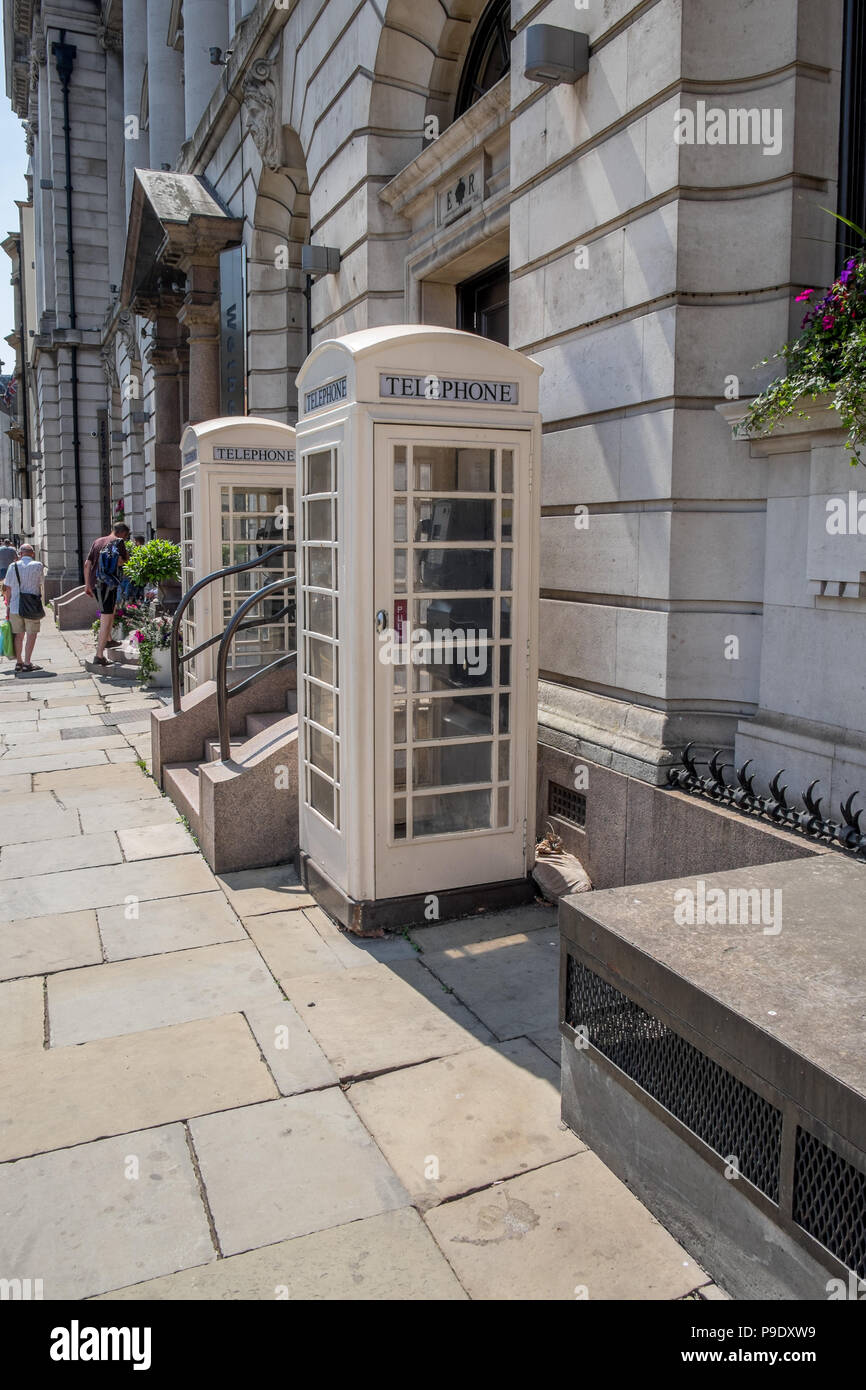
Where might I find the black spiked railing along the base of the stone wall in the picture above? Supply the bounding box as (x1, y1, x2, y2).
(667, 744, 866, 859)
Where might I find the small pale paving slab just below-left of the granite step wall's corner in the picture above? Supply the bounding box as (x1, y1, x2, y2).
(97, 891, 246, 960)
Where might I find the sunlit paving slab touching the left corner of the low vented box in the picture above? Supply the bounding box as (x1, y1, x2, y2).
(348, 1038, 587, 1211)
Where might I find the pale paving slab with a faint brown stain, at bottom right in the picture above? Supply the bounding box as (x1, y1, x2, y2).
(425, 1151, 708, 1302)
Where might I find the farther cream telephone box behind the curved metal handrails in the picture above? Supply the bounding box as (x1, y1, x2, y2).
(181, 416, 296, 689)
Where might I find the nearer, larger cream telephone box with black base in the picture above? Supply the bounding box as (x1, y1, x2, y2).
(297, 327, 541, 930)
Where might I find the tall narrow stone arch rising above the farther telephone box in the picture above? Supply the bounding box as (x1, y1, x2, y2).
(247, 126, 310, 424)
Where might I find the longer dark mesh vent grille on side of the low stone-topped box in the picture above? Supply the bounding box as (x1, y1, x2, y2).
(566, 956, 781, 1202)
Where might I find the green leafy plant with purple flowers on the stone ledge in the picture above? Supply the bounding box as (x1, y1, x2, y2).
(735, 209, 866, 466)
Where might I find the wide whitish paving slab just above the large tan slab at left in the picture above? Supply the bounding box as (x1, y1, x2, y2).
(49, 941, 281, 1047)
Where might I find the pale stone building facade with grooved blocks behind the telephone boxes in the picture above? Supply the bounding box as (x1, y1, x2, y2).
(4, 0, 866, 885)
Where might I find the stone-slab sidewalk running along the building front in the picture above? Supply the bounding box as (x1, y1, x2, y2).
(0, 620, 724, 1301)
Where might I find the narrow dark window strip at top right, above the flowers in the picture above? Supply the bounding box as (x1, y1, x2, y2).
(837, 0, 866, 265)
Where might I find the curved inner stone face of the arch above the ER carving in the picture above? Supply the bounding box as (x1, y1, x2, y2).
(370, 0, 505, 142)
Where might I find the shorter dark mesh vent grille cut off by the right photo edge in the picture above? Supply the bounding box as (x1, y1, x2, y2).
(794, 1126, 866, 1279)
